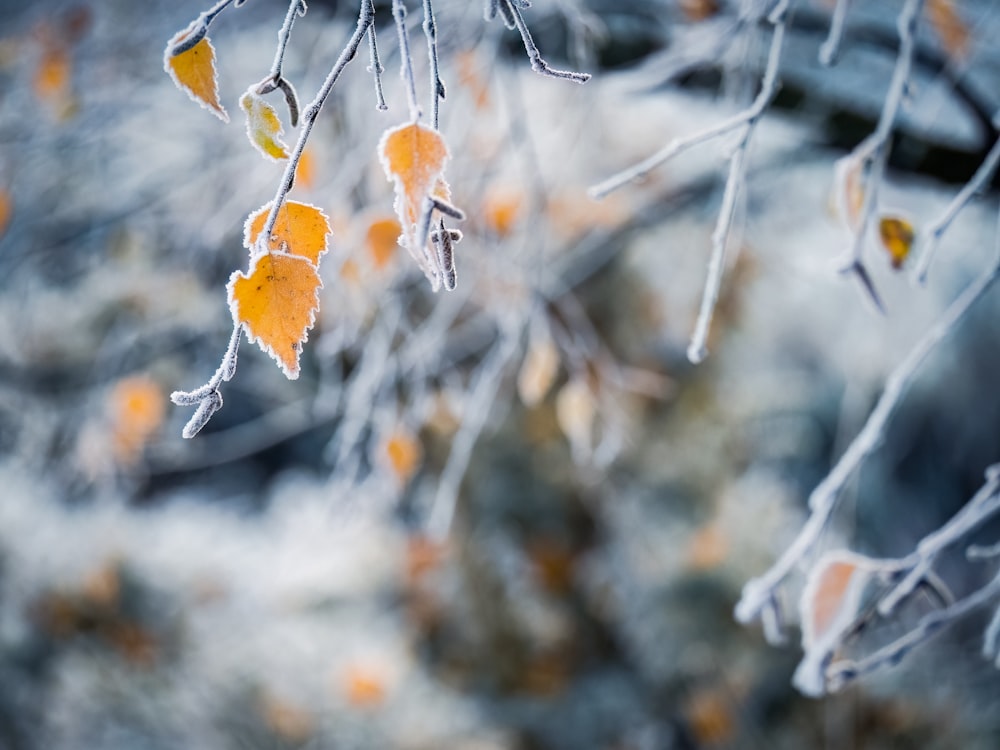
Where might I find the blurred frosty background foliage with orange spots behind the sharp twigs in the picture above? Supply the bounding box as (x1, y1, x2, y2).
(0, 0, 1000, 750)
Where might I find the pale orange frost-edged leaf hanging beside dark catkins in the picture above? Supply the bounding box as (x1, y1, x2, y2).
(378, 122, 448, 250)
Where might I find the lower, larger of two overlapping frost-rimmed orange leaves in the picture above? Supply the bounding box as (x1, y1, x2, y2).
(226, 251, 323, 380)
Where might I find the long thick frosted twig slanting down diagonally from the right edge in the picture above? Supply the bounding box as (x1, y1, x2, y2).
(735, 222, 1000, 636)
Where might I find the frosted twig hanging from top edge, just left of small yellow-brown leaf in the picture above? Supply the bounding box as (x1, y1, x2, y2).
(843, 0, 924, 310)
